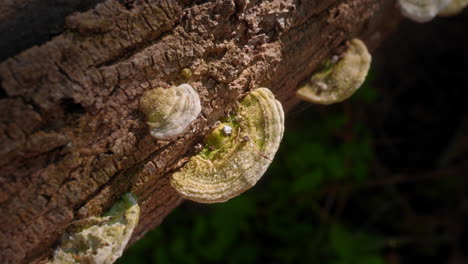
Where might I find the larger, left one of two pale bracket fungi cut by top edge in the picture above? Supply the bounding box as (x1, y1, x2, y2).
(398, 0, 451, 23)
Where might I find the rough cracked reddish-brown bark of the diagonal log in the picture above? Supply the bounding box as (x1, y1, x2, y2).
(0, 0, 400, 263)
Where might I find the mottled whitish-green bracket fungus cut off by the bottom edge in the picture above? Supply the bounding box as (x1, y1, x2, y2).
(49, 193, 140, 264)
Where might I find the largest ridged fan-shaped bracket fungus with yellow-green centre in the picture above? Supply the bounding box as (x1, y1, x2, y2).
(171, 88, 284, 203)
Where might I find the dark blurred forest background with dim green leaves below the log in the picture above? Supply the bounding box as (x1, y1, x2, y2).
(118, 10, 468, 264)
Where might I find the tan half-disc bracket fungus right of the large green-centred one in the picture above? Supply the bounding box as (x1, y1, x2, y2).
(296, 39, 371, 105)
